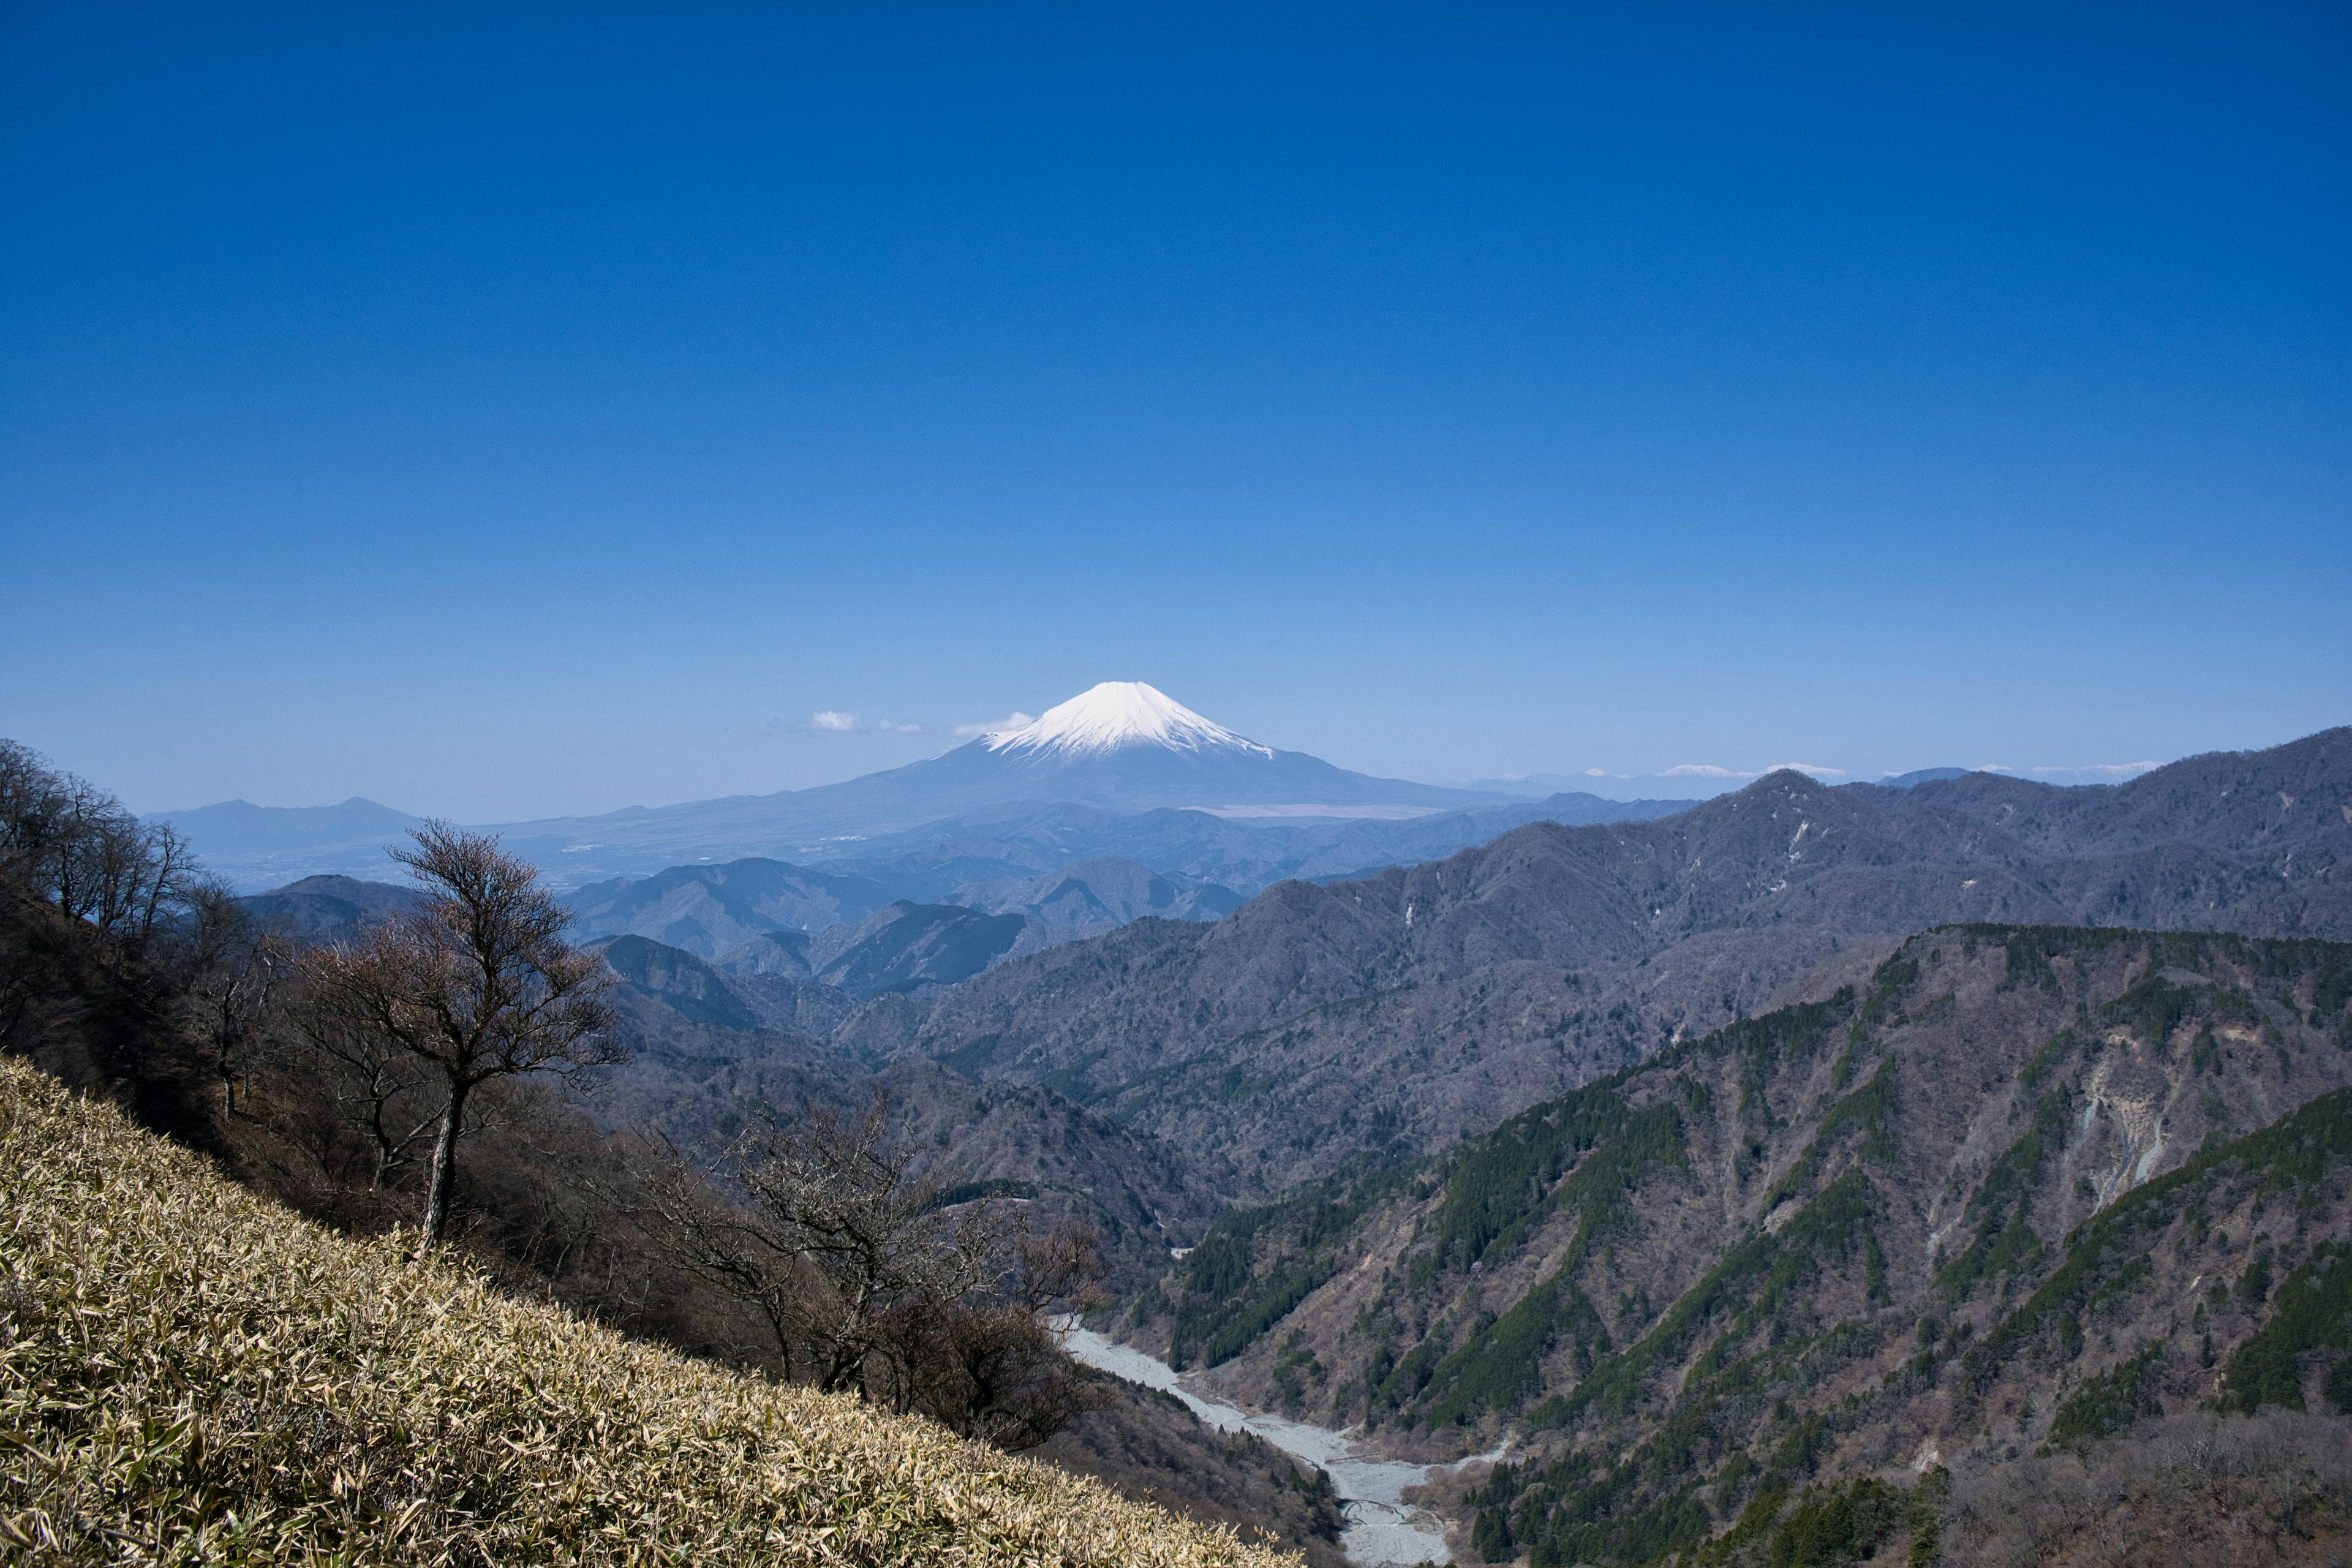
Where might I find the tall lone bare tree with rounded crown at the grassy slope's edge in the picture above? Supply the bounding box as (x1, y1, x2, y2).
(306, 823, 625, 1257)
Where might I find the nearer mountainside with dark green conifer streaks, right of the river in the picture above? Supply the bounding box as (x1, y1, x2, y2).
(1129, 926, 2352, 1566)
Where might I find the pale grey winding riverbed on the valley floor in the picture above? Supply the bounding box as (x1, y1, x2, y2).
(1061, 1326, 1503, 1568)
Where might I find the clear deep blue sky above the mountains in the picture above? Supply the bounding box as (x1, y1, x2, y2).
(0, 2, 2352, 820)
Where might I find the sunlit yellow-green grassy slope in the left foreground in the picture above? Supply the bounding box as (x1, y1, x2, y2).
(0, 1060, 1282, 1568)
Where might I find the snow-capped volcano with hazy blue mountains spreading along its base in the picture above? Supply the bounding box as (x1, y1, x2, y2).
(151, 682, 1684, 902)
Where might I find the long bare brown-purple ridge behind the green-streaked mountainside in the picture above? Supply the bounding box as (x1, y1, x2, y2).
(842, 729, 2352, 1194)
